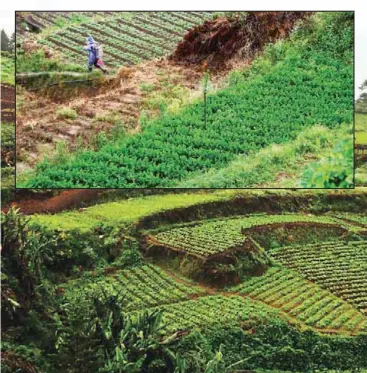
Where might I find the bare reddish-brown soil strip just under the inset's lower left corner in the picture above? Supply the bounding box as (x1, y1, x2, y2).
(2, 189, 102, 215)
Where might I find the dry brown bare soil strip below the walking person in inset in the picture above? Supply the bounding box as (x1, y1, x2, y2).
(16, 59, 206, 172)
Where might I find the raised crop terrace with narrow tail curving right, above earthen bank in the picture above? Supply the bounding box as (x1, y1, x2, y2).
(154, 214, 350, 257)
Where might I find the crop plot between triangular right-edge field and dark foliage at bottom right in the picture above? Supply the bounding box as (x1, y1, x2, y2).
(231, 267, 367, 333)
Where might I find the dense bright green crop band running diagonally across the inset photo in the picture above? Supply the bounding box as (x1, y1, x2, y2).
(27, 13, 353, 188)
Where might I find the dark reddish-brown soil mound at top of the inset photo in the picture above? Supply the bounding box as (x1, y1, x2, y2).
(171, 12, 312, 69)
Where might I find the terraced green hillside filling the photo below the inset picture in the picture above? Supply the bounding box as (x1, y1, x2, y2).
(2, 189, 367, 373)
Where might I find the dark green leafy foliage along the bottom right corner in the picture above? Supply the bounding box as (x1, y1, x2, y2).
(179, 322, 367, 373)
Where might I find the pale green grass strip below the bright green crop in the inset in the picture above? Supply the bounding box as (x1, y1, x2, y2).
(175, 125, 353, 188)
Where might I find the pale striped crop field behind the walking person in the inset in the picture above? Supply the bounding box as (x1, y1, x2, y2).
(35, 12, 212, 68)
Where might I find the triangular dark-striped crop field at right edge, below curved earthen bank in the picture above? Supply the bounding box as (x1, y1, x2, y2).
(270, 241, 367, 313)
